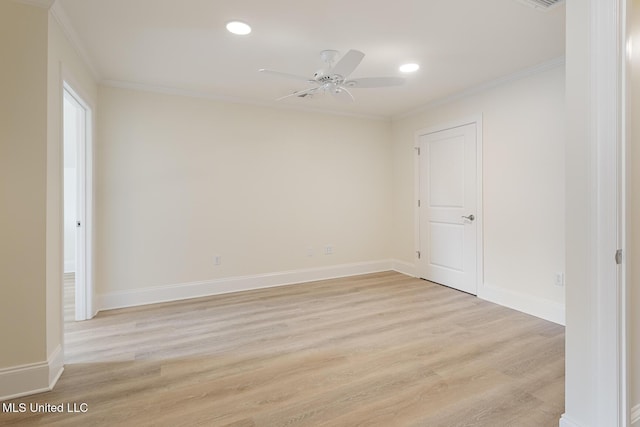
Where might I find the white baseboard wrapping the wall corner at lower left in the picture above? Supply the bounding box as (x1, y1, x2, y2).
(0, 346, 64, 401)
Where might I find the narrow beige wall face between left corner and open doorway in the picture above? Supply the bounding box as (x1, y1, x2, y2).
(47, 10, 97, 355)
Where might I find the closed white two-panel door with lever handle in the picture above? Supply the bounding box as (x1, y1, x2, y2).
(418, 123, 479, 295)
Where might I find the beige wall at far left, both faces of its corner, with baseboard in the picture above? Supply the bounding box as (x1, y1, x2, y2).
(0, 1, 97, 396)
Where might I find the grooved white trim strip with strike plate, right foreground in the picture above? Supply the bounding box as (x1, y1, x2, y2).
(587, 0, 629, 426)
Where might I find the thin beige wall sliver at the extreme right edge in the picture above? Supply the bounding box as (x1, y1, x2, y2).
(626, 0, 640, 416)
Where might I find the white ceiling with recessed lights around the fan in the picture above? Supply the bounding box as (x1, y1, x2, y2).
(54, 0, 565, 117)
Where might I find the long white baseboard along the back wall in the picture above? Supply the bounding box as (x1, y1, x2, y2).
(98, 260, 393, 310)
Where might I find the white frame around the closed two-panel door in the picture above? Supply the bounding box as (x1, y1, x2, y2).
(413, 117, 484, 295)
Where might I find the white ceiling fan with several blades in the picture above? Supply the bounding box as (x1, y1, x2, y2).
(260, 49, 404, 101)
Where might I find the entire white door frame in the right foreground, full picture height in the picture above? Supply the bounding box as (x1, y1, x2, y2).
(560, 0, 637, 427)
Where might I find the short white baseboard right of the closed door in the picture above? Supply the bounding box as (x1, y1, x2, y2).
(478, 283, 565, 325)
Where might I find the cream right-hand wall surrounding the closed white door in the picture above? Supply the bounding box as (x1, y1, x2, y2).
(393, 66, 566, 322)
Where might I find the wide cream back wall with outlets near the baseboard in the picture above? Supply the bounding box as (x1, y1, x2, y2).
(97, 87, 392, 294)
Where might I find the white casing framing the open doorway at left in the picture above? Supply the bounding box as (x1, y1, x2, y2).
(60, 78, 95, 320)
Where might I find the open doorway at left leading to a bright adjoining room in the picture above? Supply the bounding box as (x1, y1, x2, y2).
(62, 82, 93, 324)
